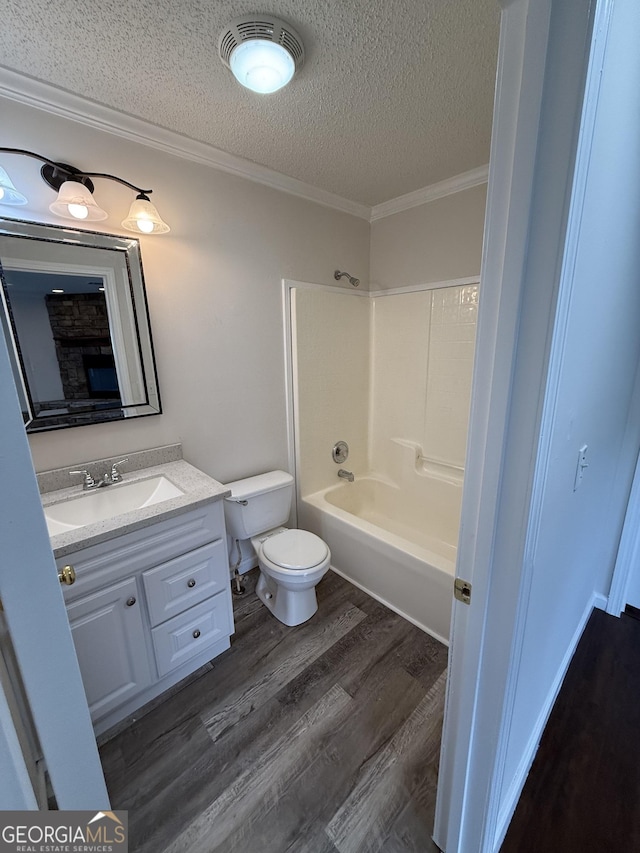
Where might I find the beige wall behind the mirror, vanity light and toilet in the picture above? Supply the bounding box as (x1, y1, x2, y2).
(0, 100, 369, 481)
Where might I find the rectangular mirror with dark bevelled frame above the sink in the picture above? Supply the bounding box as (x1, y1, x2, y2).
(0, 217, 162, 432)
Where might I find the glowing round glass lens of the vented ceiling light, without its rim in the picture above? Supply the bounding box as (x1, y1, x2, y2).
(229, 39, 296, 95)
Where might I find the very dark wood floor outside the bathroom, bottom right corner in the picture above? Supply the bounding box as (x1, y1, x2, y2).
(501, 610, 640, 853)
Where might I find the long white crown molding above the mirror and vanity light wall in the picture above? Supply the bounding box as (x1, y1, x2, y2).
(0, 65, 371, 221)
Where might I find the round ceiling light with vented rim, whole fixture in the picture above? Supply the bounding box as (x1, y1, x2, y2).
(218, 14, 304, 95)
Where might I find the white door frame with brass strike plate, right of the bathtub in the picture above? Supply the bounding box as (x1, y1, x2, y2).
(434, 0, 607, 853)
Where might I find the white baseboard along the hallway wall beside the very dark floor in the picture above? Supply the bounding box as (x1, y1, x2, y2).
(493, 592, 607, 853)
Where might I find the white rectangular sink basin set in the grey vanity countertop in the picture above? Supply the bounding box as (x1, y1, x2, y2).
(44, 474, 185, 536)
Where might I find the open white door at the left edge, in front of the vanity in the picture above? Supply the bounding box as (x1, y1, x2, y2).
(0, 320, 109, 810)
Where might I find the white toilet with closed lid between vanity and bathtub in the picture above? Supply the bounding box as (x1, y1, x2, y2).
(224, 471, 331, 626)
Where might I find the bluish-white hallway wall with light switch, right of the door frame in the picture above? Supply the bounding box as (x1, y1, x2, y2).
(502, 0, 640, 824)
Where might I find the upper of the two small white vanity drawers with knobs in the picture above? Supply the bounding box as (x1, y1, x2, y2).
(142, 539, 230, 627)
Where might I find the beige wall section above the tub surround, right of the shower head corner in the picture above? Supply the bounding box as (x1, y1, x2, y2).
(371, 184, 487, 290)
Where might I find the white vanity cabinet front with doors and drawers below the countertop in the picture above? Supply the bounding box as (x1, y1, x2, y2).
(57, 500, 233, 734)
